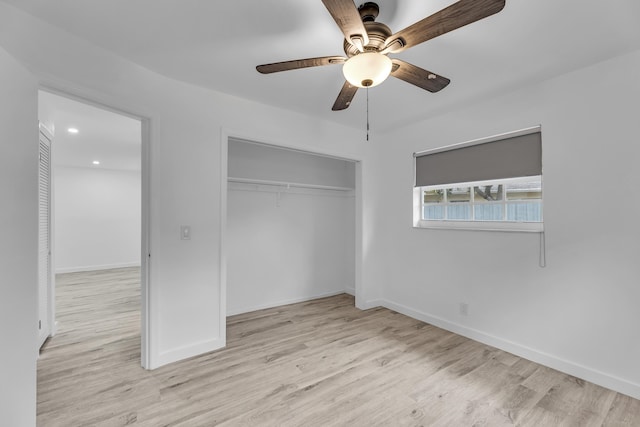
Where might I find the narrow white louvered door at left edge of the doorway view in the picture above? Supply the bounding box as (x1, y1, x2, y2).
(38, 128, 53, 346)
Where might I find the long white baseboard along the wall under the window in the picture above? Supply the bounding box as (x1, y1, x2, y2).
(379, 300, 640, 399)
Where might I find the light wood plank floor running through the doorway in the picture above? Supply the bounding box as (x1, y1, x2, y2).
(38, 268, 640, 427)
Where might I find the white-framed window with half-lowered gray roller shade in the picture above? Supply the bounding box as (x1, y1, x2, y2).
(414, 128, 543, 231)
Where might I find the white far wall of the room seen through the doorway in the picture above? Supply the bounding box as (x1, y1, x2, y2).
(53, 166, 141, 273)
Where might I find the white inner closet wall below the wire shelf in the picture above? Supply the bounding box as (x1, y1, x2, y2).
(226, 184, 355, 314)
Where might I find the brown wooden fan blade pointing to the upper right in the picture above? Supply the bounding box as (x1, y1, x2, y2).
(384, 0, 505, 53)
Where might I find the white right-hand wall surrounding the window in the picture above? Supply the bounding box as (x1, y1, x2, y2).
(364, 48, 640, 397)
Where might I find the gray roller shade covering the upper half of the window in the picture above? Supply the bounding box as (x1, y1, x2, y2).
(416, 132, 542, 187)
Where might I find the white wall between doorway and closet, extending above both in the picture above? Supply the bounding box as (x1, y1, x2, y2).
(0, 3, 369, 376)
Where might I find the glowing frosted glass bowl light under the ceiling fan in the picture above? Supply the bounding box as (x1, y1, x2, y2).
(342, 52, 391, 87)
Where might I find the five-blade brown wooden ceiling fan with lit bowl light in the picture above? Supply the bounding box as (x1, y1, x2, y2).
(256, 0, 505, 111)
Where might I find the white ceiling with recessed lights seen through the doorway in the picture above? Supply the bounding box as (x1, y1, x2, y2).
(38, 91, 142, 171)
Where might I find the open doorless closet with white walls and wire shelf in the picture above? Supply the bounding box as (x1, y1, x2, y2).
(221, 136, 362, 330)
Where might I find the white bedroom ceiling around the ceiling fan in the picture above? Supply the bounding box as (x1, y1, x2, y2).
(11, 0, 640, 131)
